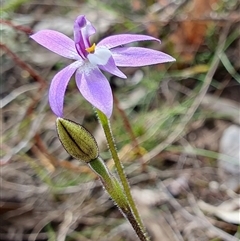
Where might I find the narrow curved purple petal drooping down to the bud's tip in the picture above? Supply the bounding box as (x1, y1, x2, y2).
(49, 62, 79, 117)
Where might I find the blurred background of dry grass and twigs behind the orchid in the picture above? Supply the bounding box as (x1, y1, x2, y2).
(0, 0, 240, 241)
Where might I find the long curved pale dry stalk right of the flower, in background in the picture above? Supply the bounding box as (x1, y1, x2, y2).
(143, 24, 231, 163)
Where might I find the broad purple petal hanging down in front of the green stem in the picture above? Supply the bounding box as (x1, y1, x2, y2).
(76, 68, 113, 118)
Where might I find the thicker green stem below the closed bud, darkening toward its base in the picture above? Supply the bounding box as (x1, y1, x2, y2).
(88, 157, 148, 241)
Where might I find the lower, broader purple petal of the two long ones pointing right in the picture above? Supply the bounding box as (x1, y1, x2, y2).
(111, 47, 175, 67)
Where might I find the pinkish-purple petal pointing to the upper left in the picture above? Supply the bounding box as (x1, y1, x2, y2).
(30, 30, 80, 59)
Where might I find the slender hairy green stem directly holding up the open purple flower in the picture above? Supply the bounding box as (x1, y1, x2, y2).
(96, 109, 146, 237)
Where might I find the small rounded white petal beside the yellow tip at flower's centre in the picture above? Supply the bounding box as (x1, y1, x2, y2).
(87, 48, 112, 65)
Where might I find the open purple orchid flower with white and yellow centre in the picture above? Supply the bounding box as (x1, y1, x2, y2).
(31, 15, 175, 118)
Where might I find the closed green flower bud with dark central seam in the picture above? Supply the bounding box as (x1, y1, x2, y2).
(56, 118, 98, 162)
